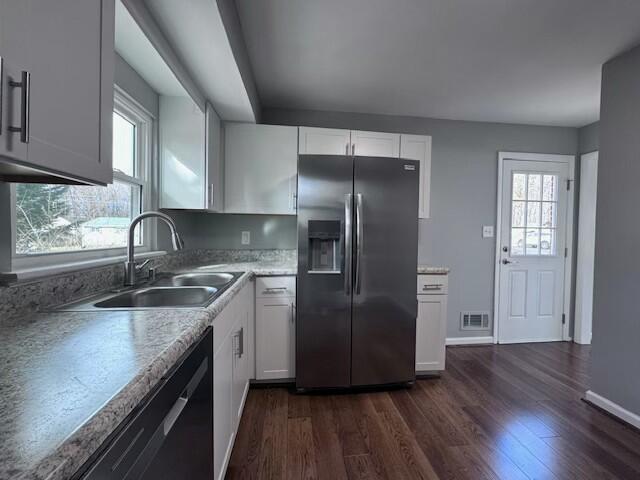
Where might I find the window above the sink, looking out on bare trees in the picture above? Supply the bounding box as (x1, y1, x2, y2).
(14, 89, 152, 263)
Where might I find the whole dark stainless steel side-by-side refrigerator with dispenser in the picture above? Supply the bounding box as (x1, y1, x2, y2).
(296, 155, 419, 391)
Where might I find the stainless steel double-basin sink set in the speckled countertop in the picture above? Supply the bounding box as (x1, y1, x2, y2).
(60, 272, 242, 311)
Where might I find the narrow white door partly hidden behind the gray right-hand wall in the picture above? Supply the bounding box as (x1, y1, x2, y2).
(573, 152, 598, 344)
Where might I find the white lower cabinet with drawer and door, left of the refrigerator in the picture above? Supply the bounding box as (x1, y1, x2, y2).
(256, 277, 296, 380)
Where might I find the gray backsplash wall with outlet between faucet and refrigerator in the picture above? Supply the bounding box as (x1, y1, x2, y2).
(158, 214, 297, 250)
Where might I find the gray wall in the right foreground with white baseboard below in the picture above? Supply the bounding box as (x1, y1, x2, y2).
(591, 47, 640, 414)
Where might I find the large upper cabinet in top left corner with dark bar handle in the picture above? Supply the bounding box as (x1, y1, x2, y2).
(0, 0, 114, 184)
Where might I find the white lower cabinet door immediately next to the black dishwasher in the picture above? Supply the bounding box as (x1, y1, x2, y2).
(213, 329, 235, 480)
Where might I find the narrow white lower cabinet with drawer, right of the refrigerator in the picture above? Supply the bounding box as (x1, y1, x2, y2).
(416, 275, 447, 374)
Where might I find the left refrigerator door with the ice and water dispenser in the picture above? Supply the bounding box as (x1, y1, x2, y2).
(296, 155, 352, 389)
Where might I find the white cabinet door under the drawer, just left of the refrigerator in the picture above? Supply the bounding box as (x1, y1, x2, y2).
(256, 297, 296, 380)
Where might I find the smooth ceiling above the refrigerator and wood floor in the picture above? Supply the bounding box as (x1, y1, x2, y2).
(236, 0, 640, 127)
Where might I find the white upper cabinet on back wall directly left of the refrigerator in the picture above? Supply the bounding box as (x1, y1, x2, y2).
(224, 123, 298, 215)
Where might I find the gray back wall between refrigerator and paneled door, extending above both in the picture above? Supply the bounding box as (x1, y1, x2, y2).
(262, 109, 578, 337)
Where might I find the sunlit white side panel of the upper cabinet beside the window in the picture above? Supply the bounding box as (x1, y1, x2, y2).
(159, 95, 206, 210)
